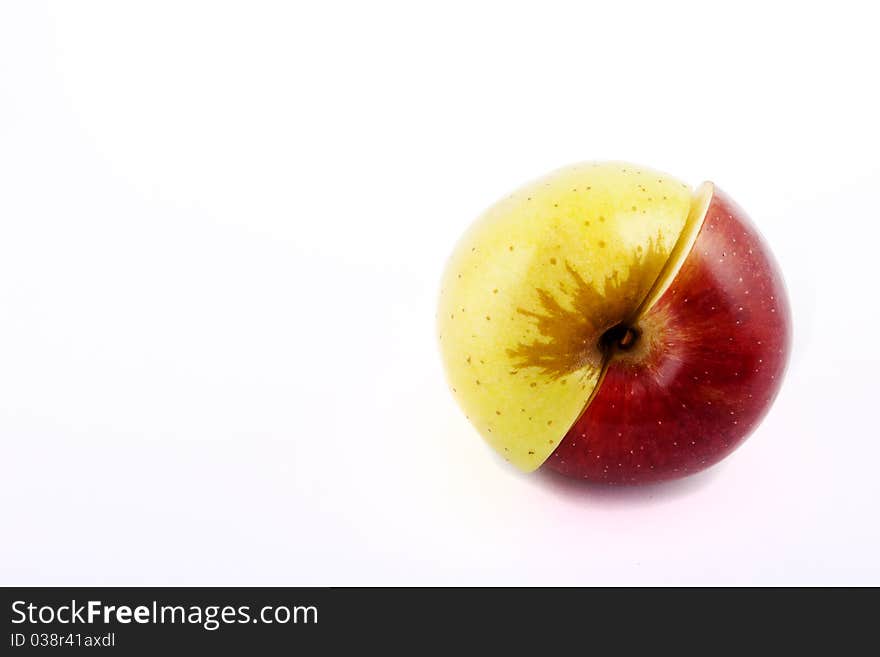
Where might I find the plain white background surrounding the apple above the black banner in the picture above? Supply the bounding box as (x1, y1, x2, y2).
(0, 0, 880, 585)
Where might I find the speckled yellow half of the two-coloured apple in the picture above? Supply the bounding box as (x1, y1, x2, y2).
(437, 162, 692, 472)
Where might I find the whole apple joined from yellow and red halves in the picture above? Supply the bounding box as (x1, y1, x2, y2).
(437, 162, 791, 484)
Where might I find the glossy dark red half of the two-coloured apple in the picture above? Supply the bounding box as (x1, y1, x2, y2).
(545, 189, 791, 484)
